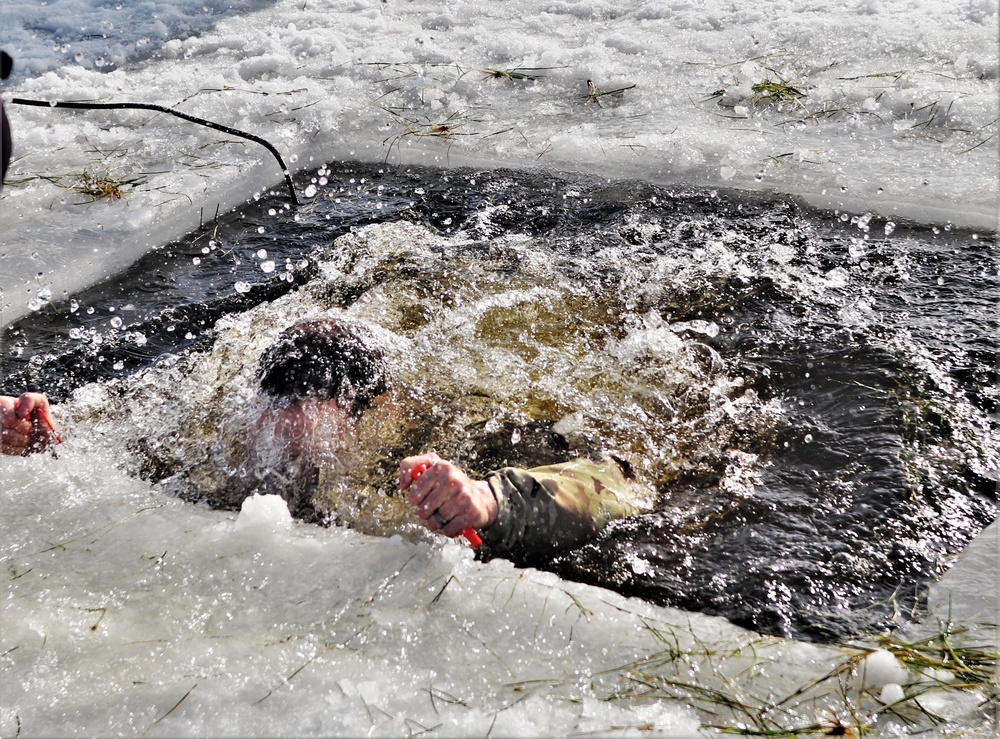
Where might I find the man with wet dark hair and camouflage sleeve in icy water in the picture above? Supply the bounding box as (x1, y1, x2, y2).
(0, 319, 642, 563)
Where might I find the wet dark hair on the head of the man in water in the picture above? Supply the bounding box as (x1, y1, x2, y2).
(257, 319, 389, 416)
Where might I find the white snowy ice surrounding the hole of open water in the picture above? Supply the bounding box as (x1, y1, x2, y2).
(0, 0, 998, 736)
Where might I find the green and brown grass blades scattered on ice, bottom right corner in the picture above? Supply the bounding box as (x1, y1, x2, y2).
(592, 623, 1000, 737)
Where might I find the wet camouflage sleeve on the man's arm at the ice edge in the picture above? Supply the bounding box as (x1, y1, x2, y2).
(482, 458, 638, 562)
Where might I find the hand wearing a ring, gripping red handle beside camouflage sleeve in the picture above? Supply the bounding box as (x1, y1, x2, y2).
(399, 452, 497, 537)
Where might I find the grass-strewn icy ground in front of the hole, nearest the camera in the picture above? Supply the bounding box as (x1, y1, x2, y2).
(0, 448, 998, 737)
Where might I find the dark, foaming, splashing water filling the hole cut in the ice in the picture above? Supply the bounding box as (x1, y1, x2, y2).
(3, 166, 998, 638)
